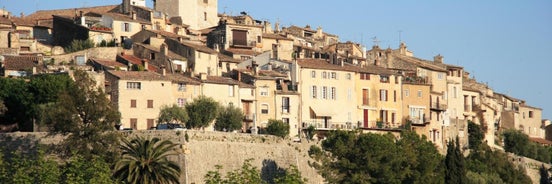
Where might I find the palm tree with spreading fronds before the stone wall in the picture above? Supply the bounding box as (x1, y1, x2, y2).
(114, 137, 180, 184)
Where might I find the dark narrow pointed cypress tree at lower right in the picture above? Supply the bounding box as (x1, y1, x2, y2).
(445, 138, 467, 184)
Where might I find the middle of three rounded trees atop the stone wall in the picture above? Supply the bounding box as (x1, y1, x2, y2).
(186, 96, 219, 129)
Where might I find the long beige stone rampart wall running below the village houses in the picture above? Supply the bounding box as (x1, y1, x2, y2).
(0, 130, 323, 184)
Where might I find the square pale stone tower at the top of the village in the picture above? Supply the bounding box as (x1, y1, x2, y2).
(153, 0, 219, 30)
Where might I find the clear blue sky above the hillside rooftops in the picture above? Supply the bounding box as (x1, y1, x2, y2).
(4, 0, 552, 119)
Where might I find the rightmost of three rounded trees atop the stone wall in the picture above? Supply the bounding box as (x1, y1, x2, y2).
(215, 105, 243, 132)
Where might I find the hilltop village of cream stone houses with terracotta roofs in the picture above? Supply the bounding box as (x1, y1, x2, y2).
(0, 0, 552, 152)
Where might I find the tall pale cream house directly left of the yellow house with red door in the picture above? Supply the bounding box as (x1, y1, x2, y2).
(292, 59, 358, 130)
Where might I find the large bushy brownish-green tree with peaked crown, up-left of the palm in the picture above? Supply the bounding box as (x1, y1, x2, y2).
(41, 70, 120, 162)
